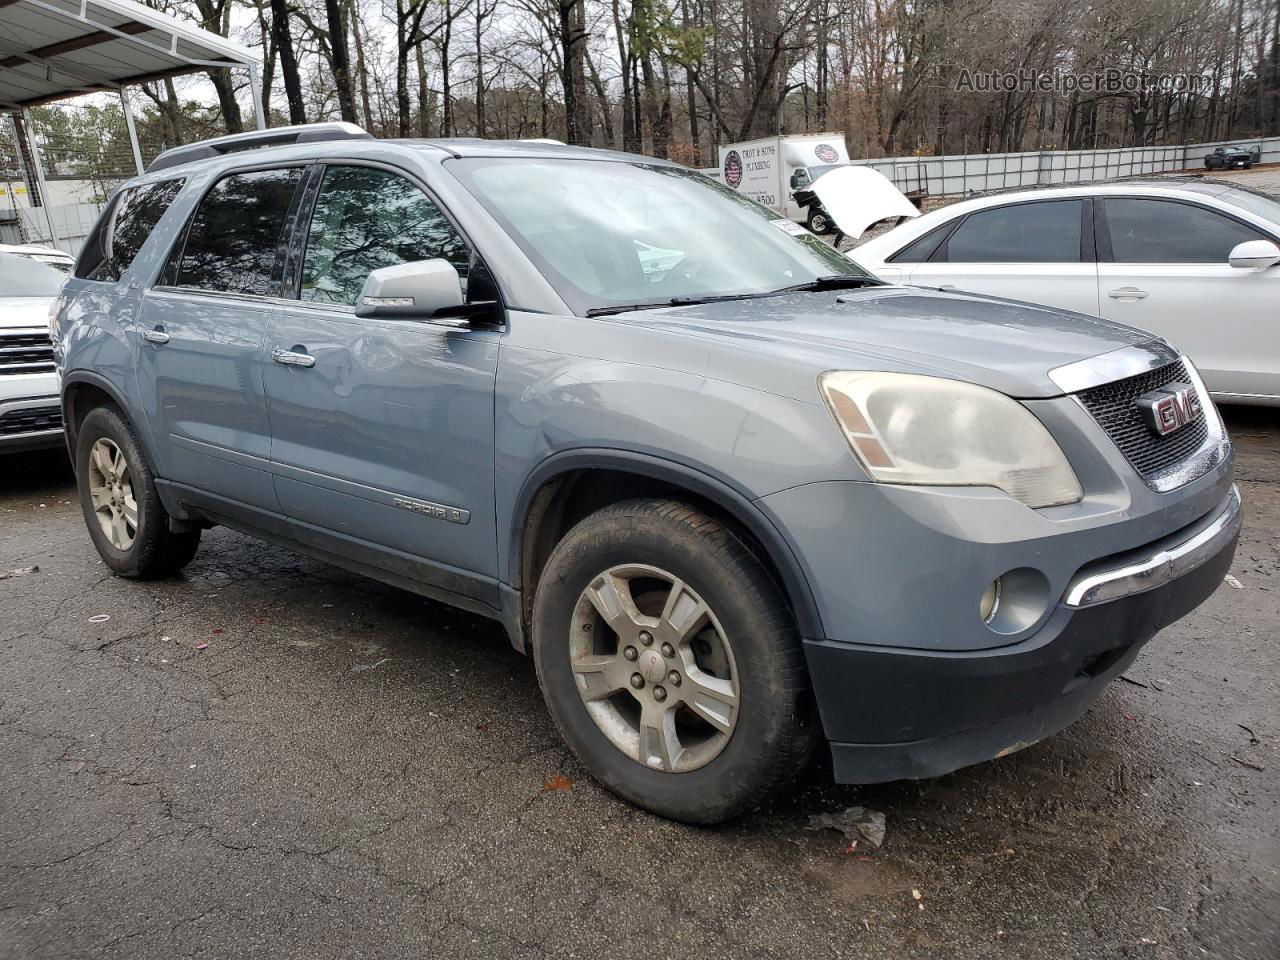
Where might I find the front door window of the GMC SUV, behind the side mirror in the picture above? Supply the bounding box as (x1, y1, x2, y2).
(301, 166, 471, 306)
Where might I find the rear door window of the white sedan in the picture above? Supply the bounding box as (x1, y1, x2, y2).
(945, 200, 1082, 264)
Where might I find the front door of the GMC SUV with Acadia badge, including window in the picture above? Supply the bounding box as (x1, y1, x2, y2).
(265, 165, 500, 605)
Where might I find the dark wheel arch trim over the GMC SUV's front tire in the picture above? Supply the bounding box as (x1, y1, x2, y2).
(506, 449, 824, 649)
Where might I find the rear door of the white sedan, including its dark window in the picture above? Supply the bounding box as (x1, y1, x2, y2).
(901, 197, 1098, 315)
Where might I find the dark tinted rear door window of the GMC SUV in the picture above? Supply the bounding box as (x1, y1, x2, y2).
(175, 166, 302, 297)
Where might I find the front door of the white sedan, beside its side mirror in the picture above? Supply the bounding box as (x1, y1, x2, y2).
(1098, 197, 1280, 396)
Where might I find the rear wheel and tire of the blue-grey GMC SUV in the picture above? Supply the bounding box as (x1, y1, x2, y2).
(76, 406, 200, 580)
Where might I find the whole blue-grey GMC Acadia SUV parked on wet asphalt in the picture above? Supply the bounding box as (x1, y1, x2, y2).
(51, 124, 1240, 823)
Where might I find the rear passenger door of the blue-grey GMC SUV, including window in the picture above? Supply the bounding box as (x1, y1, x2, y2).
(138, 165, 306, 512)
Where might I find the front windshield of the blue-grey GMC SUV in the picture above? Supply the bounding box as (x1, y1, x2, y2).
(448, 157, 870, 312)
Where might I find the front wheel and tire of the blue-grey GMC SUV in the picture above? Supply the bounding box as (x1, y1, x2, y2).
(532, 499, 814, 823)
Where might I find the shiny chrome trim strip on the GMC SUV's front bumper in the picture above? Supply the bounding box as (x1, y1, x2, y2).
(1062, 484, 1242, 607)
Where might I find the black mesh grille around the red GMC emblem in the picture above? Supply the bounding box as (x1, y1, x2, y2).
(1075, 360, 1211, 477)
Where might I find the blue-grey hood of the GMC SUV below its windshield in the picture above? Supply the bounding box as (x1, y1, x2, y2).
(613, 287, 1155, 398)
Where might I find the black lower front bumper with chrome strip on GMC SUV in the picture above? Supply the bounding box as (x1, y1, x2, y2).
(805, 488, 1240, 783)
